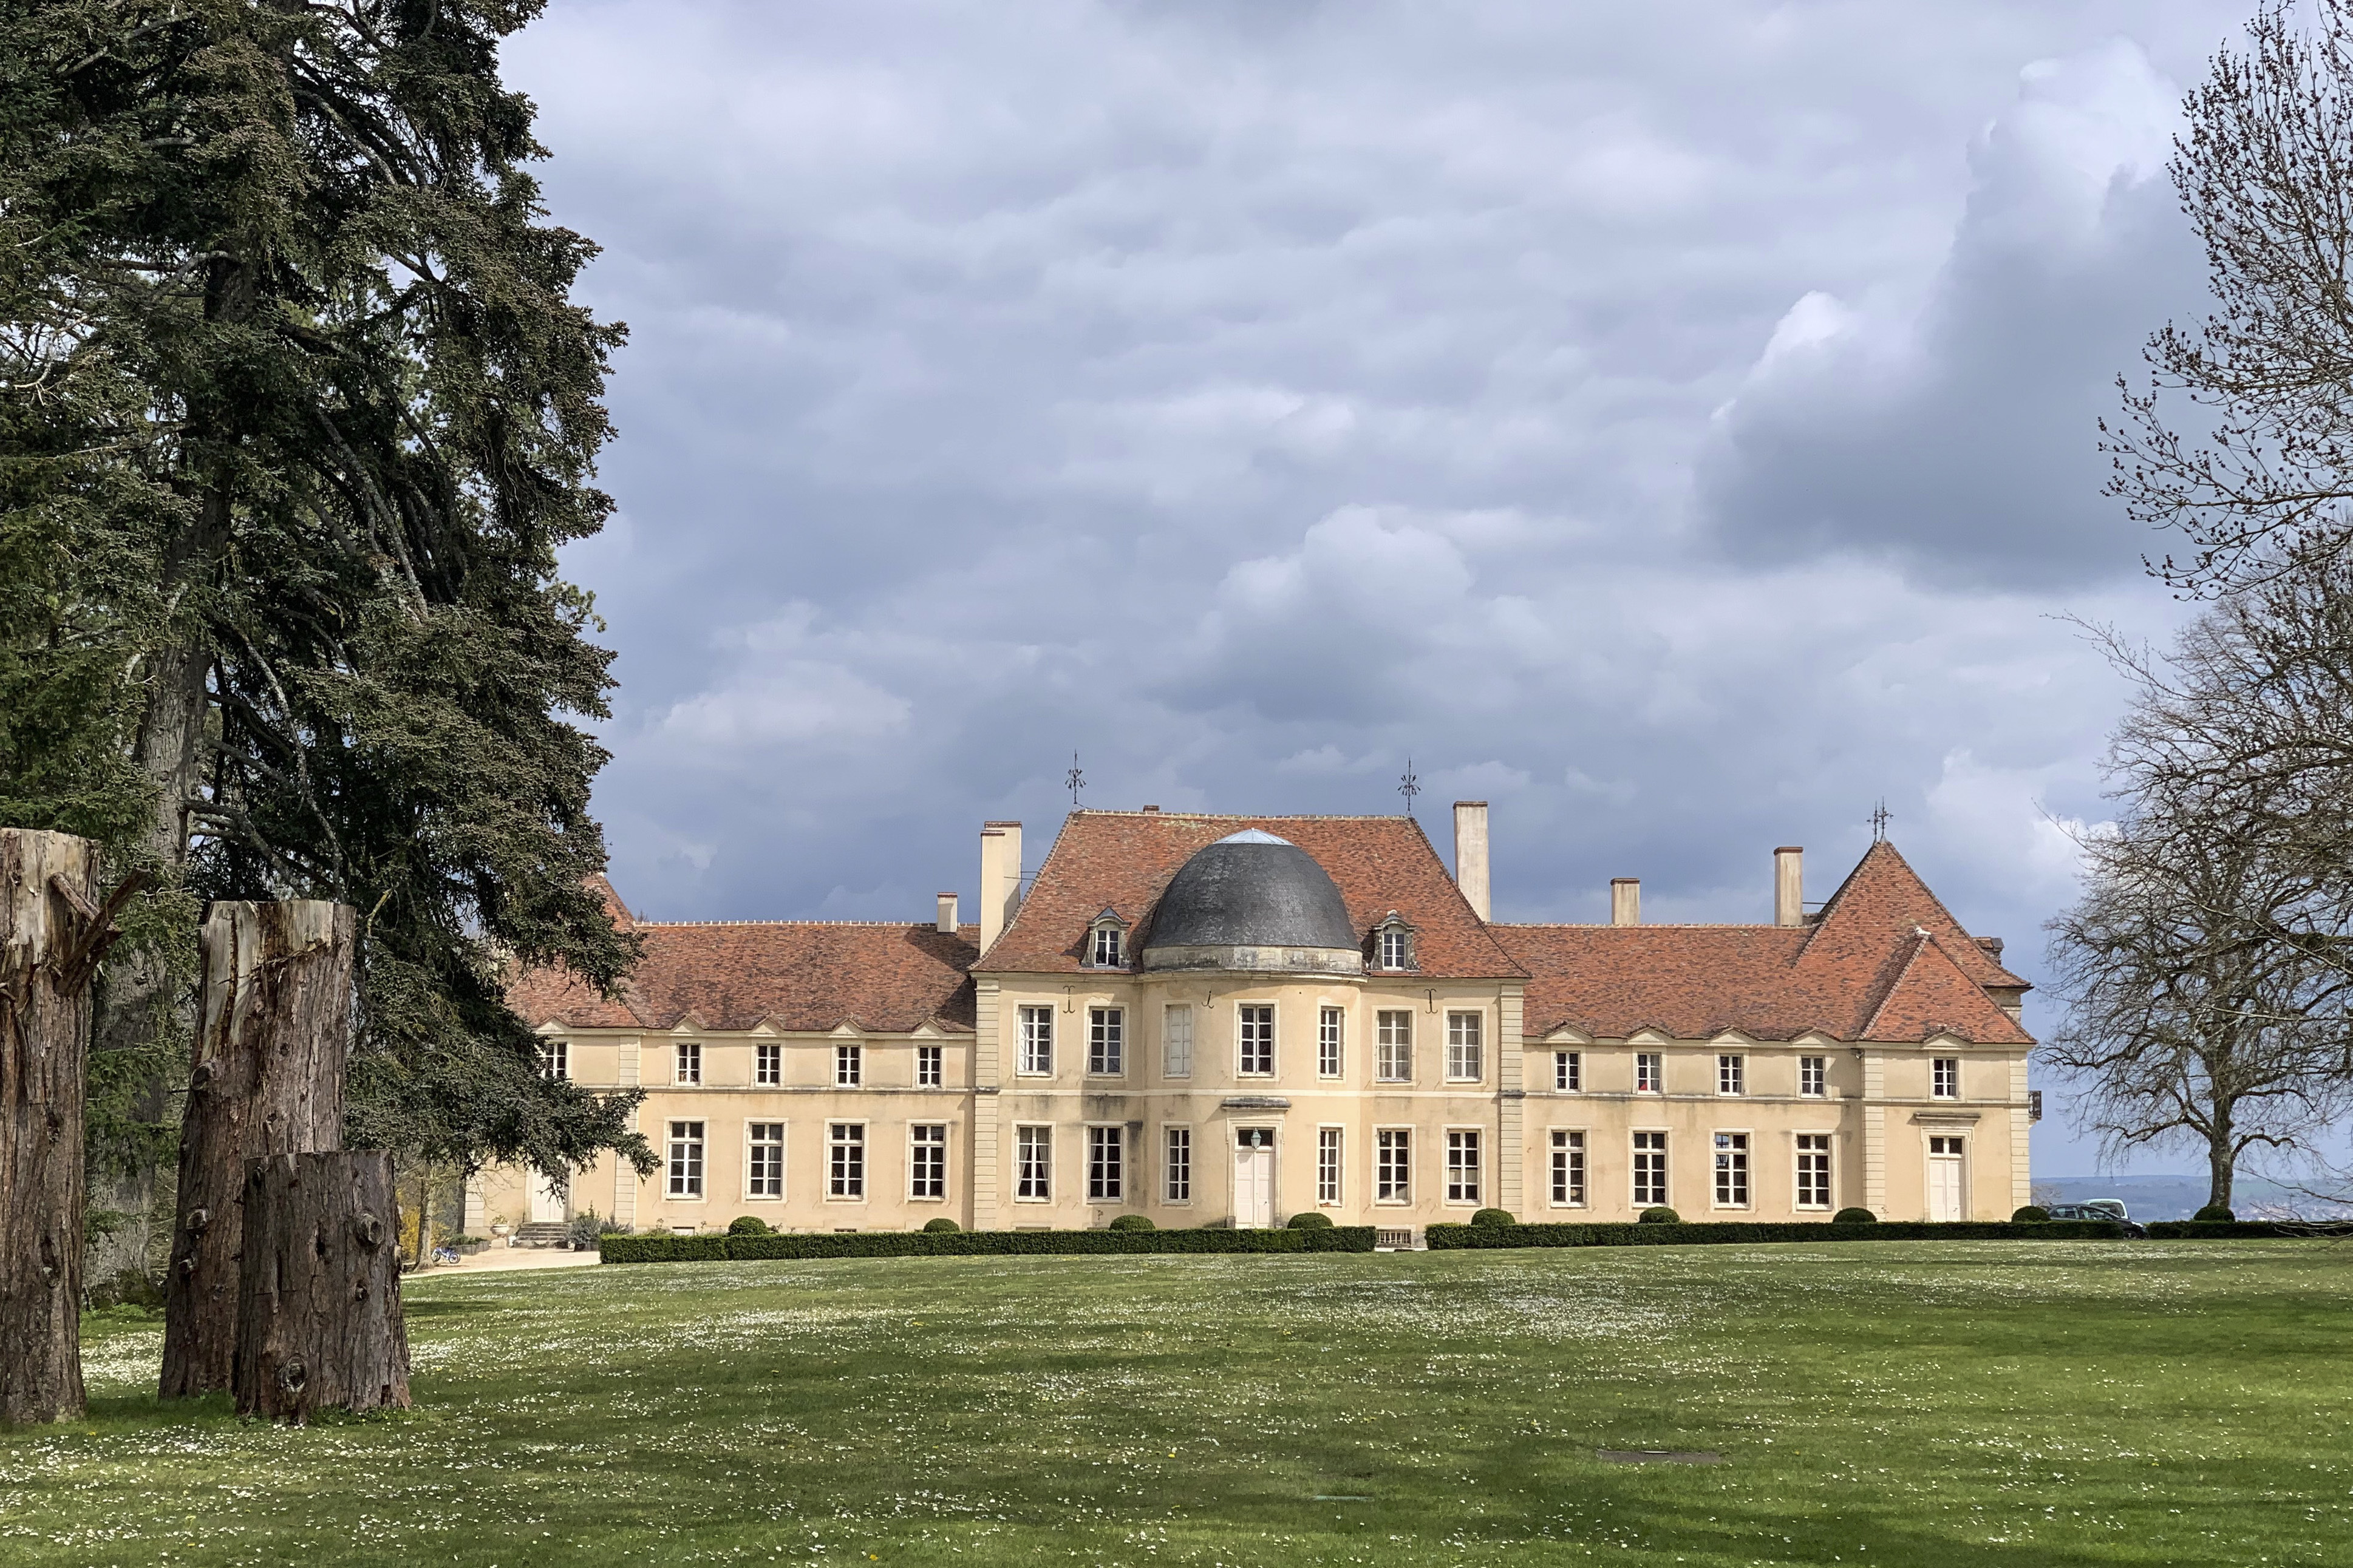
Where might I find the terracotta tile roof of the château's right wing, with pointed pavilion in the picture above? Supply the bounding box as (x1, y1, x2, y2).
(1492, 844, 2033, 1044)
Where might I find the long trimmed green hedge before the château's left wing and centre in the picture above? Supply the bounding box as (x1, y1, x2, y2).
(598, 1225, 1372, 1263)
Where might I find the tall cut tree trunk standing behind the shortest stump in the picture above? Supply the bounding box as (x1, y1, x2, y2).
(162, 898, 358, 1399)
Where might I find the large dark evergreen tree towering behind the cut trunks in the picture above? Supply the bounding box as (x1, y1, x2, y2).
(0, 0, 645, 1203)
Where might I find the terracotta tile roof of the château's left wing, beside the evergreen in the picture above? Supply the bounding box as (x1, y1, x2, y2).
(508, 921, 979, 1034)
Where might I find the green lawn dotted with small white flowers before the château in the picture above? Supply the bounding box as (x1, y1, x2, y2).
(0, 1241, 2353, 1568)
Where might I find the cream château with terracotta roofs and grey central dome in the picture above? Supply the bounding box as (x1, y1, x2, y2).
(468, 802, 2033, 1244)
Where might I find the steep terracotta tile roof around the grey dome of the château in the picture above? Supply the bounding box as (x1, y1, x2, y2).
(981, 811, 1520, 978)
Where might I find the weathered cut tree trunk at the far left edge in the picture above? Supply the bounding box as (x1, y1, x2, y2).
(0, 827, 108, 1422)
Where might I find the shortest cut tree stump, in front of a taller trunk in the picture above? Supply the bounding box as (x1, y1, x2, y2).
(236, 1150, 409, 1427)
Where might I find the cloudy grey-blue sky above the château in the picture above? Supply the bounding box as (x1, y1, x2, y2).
(508, 0, 2247, 1173)
